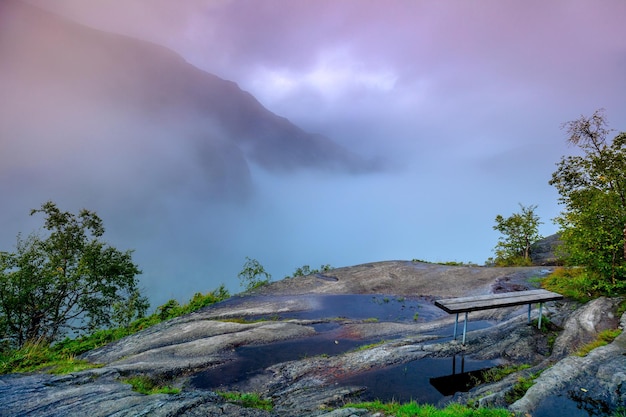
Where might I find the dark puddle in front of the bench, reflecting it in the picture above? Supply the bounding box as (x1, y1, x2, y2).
(339, 356, 498, 404)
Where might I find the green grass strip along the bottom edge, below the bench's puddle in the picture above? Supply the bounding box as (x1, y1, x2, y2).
(345, 401, 511, 417)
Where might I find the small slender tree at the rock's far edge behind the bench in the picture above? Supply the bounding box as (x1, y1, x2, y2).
(493, 204, 542, 265)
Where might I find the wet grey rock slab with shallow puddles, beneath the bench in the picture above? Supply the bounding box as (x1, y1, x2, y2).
(0, 261, 626, 417)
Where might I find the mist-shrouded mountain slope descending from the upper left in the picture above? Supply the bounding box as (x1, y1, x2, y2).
(0, 0, 372, 199)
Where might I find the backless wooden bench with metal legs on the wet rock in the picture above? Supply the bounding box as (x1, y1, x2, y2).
(435, 290, 563, 344)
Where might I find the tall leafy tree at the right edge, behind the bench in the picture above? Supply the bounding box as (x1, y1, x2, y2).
(550, 109, 626, 286)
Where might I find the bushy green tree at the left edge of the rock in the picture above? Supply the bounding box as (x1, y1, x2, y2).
(0, 201, 148, 347)
